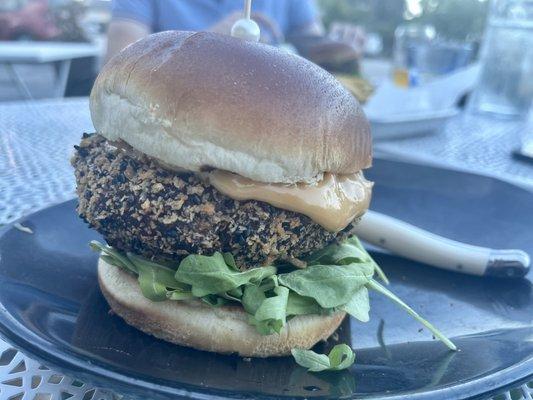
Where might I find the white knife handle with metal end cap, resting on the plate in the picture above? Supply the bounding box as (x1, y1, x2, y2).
(354, 210, 530, 277)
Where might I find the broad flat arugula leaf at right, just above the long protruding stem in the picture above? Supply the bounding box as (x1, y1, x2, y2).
(278, 263, 374, 308)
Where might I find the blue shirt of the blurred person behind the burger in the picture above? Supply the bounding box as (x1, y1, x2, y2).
(112, 0, 317, 35)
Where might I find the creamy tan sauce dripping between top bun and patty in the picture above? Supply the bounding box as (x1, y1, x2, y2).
(208, 170, 373, 232)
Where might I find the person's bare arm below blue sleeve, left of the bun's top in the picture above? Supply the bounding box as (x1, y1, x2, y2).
(105, 19, 151, 62)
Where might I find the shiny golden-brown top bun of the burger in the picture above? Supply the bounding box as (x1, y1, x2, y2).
(90, 31, 372, 182)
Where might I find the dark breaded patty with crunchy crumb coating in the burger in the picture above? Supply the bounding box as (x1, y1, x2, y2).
(72, 134, 351, 269)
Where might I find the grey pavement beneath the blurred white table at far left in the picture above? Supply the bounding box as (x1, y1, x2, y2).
(0, 64, 55, 101)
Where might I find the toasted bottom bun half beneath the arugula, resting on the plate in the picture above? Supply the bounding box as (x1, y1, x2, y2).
(98, 258, 346, 357)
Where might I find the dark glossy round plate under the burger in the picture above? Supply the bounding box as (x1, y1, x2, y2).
(0, 160, 533, 399)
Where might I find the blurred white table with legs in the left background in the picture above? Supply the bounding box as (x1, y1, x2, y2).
(0, 41, 104, 99)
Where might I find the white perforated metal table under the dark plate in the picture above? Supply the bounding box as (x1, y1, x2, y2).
(0, 98, 533, 400)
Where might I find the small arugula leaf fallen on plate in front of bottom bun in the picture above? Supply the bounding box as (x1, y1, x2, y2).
(291, 343, 355, 372)
